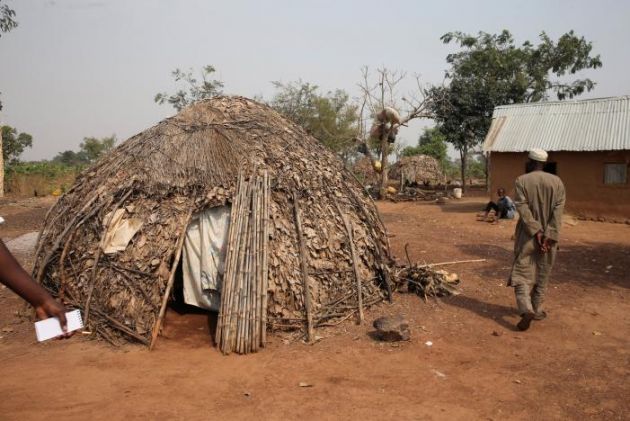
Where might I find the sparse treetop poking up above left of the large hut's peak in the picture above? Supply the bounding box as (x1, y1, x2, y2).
(153, 65, 223, 111)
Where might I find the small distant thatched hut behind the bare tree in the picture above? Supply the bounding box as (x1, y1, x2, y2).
(389, 155, 446, 187)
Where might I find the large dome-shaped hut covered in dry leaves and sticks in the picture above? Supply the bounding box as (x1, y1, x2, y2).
(34, 97, 390, 353)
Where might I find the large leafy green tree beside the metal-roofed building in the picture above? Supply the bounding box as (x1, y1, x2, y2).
(432, 30, 602, 191)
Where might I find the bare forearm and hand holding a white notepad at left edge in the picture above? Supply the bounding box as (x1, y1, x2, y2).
(0, 240, 67, 330)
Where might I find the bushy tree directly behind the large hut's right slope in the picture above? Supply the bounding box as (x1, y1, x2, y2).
(270, 80, 359, 164)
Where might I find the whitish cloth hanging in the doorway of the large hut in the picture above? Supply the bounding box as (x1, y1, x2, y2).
(182, 206, 230, 311)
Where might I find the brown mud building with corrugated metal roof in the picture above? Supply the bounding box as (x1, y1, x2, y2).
(483, 96, 630, 221)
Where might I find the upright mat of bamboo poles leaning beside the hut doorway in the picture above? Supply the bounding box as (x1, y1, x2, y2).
(216, 171, 270, 354)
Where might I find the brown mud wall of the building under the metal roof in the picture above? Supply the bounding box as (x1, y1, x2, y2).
(490, 151, 630, 222)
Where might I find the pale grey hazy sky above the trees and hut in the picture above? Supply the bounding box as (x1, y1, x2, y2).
(0, 0, 630, 159)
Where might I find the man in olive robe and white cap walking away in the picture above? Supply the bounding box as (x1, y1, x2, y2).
(508, 149, 565, 331)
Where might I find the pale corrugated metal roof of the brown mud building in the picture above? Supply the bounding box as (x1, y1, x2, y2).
(483, 95, 630, 152)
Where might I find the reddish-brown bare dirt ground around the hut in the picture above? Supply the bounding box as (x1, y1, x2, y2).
(0, 198, 630, 420)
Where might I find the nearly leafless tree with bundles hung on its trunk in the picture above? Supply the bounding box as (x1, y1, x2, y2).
(357, 67, 437, 197)
